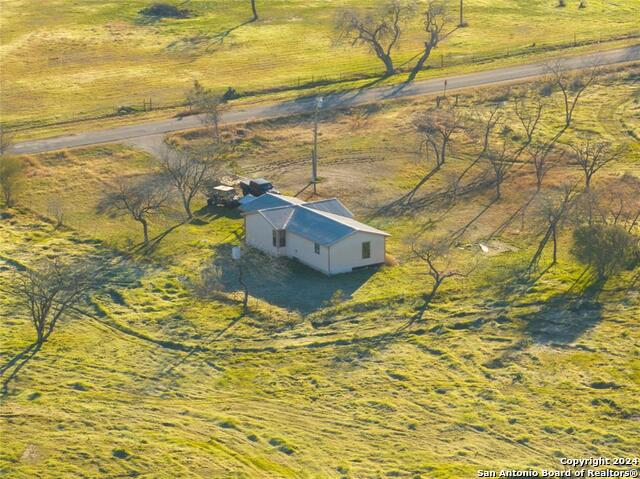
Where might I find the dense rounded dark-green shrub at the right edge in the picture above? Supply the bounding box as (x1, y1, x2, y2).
(572, 225, 640, 279)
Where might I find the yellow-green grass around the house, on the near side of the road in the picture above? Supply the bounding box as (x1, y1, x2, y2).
(0, 75, 640, 478)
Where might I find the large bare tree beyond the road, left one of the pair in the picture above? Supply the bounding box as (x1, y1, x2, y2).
(336, 0, 408, 76)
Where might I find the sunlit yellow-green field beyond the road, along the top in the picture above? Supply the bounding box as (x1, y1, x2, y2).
(0, 0, 640, 131)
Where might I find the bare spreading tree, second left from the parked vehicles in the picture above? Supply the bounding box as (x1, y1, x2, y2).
(98, 174, 170, 245)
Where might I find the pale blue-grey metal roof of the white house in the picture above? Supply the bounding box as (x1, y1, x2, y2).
(243, 195, 389, 246)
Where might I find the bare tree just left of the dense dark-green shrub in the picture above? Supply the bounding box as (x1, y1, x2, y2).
(529, 184, 576, 271)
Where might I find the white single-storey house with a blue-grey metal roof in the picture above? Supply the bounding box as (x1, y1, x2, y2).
(240, 193, 389, 275)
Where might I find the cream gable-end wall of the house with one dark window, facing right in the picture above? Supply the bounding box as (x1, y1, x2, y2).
(329, 231, 385, 274)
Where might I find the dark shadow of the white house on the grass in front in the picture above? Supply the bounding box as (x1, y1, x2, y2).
(208, 244, 378, 314)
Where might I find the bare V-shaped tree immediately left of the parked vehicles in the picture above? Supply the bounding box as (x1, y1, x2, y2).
(159, 143, 226, 220)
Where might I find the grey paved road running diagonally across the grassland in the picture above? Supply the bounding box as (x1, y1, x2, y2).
(13, 45, 640, 153)
